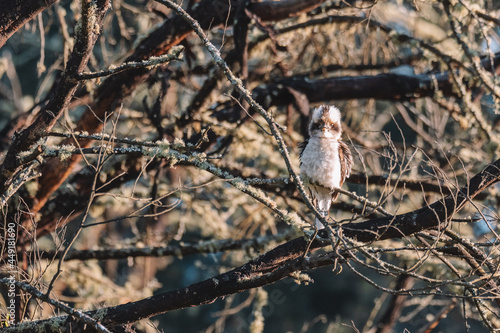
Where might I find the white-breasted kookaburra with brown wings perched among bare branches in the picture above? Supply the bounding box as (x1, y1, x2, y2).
(299, 105, 352, 230)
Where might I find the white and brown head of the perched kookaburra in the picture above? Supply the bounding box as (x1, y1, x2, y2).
(309, 105, 342, 140)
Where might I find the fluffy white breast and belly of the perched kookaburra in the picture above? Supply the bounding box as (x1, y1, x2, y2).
(300, 137, 341, 189)
